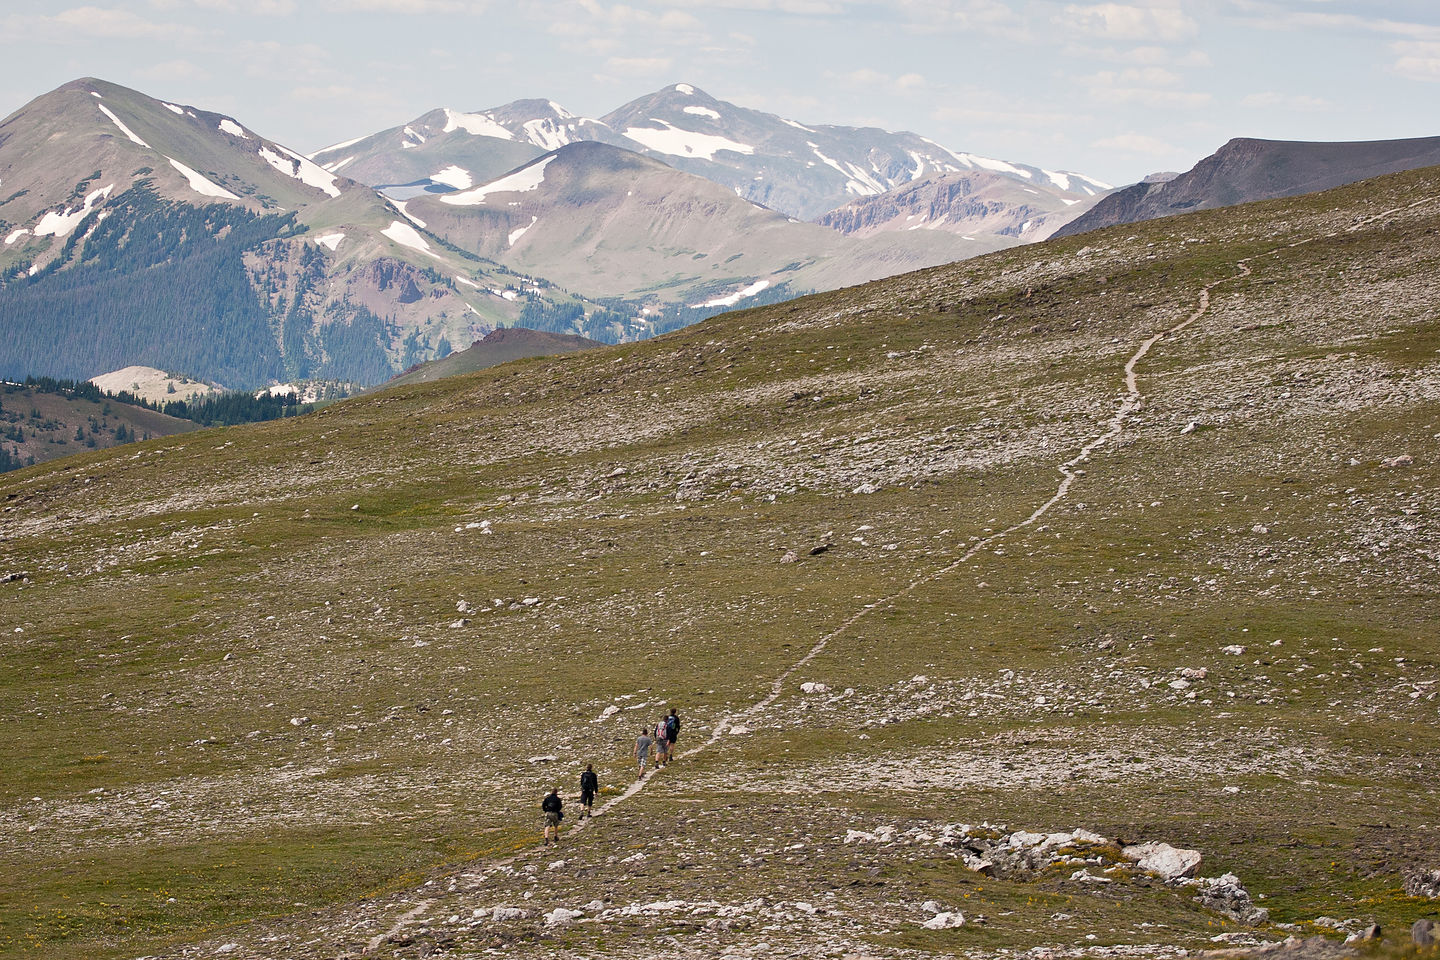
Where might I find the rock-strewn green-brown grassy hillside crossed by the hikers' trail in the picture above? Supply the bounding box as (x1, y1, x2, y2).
(0, 170, 1440, 959)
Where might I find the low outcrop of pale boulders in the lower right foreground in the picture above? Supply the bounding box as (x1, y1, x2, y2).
(845, 823, 1270, 927)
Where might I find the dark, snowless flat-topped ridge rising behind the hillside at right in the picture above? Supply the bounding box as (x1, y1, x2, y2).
(1056, 137, 1440, 236)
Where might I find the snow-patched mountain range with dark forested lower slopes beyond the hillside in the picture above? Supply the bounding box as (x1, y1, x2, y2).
(0, 78, 1103, 387)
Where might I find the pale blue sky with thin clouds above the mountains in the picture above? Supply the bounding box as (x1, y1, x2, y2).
(0, 0, 1440, 184)
